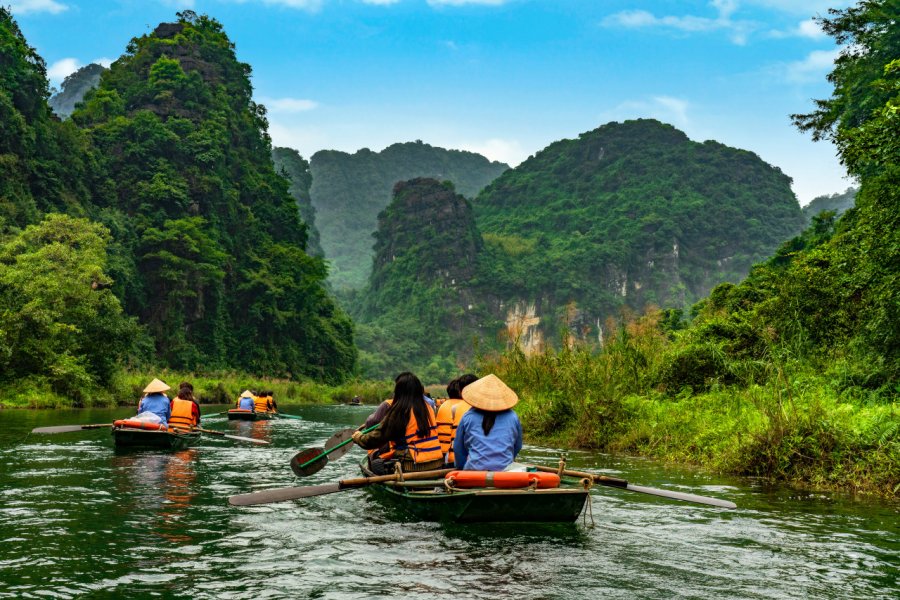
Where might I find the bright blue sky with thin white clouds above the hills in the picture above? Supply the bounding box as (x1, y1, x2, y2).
(15, 0, 851, 204)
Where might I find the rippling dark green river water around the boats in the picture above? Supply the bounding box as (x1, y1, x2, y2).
(0, 406, 900, 600)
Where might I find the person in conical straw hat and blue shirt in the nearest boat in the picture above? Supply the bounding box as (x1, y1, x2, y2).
(453, 373, 522, 471)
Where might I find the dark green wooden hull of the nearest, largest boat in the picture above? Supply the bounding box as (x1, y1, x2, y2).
(360, 460, 590, 523)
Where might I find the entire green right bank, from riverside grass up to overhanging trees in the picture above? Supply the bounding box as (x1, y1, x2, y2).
(484, 0, 900, 495)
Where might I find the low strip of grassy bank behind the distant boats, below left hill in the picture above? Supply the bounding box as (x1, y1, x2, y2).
(0, 369, 393, 408)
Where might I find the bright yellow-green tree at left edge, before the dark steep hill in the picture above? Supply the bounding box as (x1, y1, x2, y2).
(0, 214, 140, 404)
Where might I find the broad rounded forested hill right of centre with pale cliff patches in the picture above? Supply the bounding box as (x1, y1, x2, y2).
(474, 120, 804, 346)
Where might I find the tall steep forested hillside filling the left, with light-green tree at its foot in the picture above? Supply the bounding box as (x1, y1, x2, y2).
(0, 7, 356, 402)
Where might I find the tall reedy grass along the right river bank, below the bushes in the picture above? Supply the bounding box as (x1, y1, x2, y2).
(480, 319, 900, 497)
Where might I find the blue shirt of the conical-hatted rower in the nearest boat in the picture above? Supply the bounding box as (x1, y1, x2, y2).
(453, 408, 522, 471)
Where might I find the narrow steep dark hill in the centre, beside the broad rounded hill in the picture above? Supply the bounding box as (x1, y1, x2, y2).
(354, 178, 493, 382)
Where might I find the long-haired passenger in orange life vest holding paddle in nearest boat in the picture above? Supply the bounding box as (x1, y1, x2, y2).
(353, 373, 444, 475)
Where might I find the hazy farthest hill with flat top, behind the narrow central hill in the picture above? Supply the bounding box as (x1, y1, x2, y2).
(310, 141, 509, 289)
